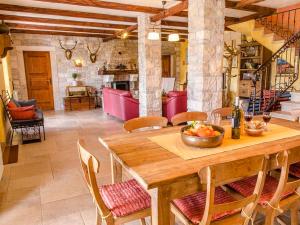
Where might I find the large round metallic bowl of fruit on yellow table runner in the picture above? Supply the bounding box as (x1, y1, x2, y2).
(181, 122, 225, 148)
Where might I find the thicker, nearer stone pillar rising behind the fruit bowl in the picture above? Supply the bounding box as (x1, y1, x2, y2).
(187, 0, 225, 112)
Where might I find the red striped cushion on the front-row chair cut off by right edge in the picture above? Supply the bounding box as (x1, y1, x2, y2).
(228, 176, 293, 204)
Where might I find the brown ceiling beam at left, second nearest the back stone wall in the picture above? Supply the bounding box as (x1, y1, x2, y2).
(0, 14, 128, 30)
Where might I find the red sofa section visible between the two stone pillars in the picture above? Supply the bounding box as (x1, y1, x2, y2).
(162, 91, 187, 122)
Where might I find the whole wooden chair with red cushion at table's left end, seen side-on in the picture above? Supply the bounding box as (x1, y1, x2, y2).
(77, 140, 151, 225)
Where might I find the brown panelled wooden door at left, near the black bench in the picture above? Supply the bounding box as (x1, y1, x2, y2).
(23, 51, 54, 110)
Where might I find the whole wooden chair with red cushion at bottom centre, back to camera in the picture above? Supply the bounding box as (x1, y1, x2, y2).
(171, 155, 268, 225)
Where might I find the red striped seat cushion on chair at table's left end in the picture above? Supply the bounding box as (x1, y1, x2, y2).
(100, 180, 151, 217)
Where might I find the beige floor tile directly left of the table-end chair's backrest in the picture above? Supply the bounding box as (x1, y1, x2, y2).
(41, 174, 88, 204)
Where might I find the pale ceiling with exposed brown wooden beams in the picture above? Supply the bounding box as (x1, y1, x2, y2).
(0, 0, 275, 41)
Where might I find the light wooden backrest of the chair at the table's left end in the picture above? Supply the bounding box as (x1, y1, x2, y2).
(77, 140, 111, 217)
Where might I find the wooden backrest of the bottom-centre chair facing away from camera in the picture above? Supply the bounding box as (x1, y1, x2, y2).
(199, 155, 268, 225)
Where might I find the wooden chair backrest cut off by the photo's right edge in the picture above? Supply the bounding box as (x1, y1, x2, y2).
(266, 147, 300, 209)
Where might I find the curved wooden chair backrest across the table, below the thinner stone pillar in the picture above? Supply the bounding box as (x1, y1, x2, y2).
(124, 116, 168, 132)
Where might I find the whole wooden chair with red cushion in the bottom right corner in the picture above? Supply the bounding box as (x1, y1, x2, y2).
(228, 148, 300, 225)
